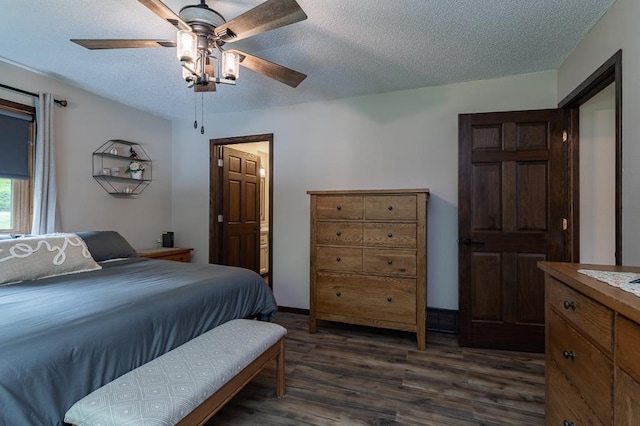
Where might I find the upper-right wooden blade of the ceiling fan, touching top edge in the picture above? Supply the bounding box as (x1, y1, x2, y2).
(215, 0, 307, 42)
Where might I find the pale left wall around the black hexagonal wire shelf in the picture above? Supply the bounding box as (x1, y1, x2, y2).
(0, 58, 172, 248)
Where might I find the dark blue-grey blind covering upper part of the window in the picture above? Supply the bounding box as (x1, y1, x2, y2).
(0, 109, 33, 179)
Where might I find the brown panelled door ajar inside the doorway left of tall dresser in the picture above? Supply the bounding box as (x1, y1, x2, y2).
(221, 146, 260, 273)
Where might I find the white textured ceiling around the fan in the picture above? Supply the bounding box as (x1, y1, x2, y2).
(0, 0, 614, 118)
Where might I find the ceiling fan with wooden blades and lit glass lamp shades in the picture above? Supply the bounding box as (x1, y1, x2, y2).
(71, 0, 307, 92)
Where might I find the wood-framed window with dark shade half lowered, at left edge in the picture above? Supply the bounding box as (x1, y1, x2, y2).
(0, 99, 35, 233)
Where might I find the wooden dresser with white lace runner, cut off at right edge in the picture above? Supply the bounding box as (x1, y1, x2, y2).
(538, 262, 640, 426)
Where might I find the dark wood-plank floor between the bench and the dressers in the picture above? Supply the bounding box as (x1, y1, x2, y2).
(207, 312, 544, 426)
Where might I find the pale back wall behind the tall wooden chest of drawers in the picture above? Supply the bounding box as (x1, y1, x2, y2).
(172, 72, 557, 309)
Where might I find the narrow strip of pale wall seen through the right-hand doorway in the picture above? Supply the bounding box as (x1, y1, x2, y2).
(580, 84, 616, 265)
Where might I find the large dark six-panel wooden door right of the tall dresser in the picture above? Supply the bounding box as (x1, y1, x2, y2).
(458, 110, 566, 352)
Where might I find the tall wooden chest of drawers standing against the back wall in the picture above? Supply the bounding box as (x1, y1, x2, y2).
(308, 189, 429, 350)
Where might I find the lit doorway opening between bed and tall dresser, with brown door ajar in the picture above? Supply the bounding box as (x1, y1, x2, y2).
(209, 134, 273, 288)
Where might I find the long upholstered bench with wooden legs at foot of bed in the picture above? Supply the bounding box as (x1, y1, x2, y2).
(64, 319, 287, 426)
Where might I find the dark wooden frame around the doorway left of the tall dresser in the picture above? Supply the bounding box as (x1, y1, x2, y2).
(209, 133, 273, 290)
